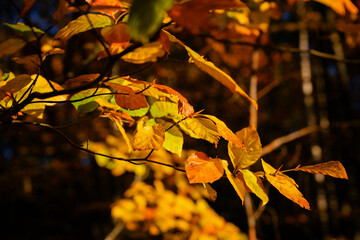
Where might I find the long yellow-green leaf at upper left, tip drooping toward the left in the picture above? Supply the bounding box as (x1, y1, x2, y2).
(54, 13, 113, 39)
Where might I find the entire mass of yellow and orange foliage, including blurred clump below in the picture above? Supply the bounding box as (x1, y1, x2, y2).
(0, 0, 358, 239)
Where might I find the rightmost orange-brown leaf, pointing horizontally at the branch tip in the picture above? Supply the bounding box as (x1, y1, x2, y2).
(296, 161, 348, 179)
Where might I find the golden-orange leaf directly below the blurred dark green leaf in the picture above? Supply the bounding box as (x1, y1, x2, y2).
(121, 42, 165, 64)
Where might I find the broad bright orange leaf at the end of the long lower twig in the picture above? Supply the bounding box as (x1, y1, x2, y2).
(185, 152, 224, 183)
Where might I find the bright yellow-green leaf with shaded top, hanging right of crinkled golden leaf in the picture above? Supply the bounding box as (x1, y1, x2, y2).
(156, 119, 184, 157)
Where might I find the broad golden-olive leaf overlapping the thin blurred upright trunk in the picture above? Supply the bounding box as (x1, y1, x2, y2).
(228, 126, 262, 170)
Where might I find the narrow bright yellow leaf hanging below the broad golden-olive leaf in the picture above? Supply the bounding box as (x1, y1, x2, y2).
(237, 169, 269, 206)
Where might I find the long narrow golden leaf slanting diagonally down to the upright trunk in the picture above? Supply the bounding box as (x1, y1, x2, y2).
(165, 31, 258, 109)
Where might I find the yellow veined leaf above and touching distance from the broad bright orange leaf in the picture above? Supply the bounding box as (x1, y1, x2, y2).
(179, 117, 220, 146)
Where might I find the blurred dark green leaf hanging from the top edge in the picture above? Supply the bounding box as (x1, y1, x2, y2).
(128, 0, 173, 43)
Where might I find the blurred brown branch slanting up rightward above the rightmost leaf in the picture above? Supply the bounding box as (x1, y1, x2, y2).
(261, 126, 321, 156)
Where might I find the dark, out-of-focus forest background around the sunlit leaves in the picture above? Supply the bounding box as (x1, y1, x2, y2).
(0, 0, 360, 240)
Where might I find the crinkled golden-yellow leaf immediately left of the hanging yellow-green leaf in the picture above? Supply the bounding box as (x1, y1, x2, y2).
(132, 120, 165, 150)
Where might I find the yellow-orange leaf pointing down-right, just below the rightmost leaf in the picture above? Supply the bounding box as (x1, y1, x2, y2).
(262, 161, 310, 210)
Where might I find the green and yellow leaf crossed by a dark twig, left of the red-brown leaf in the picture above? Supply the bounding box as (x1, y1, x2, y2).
(70, 88, 112, 113)
